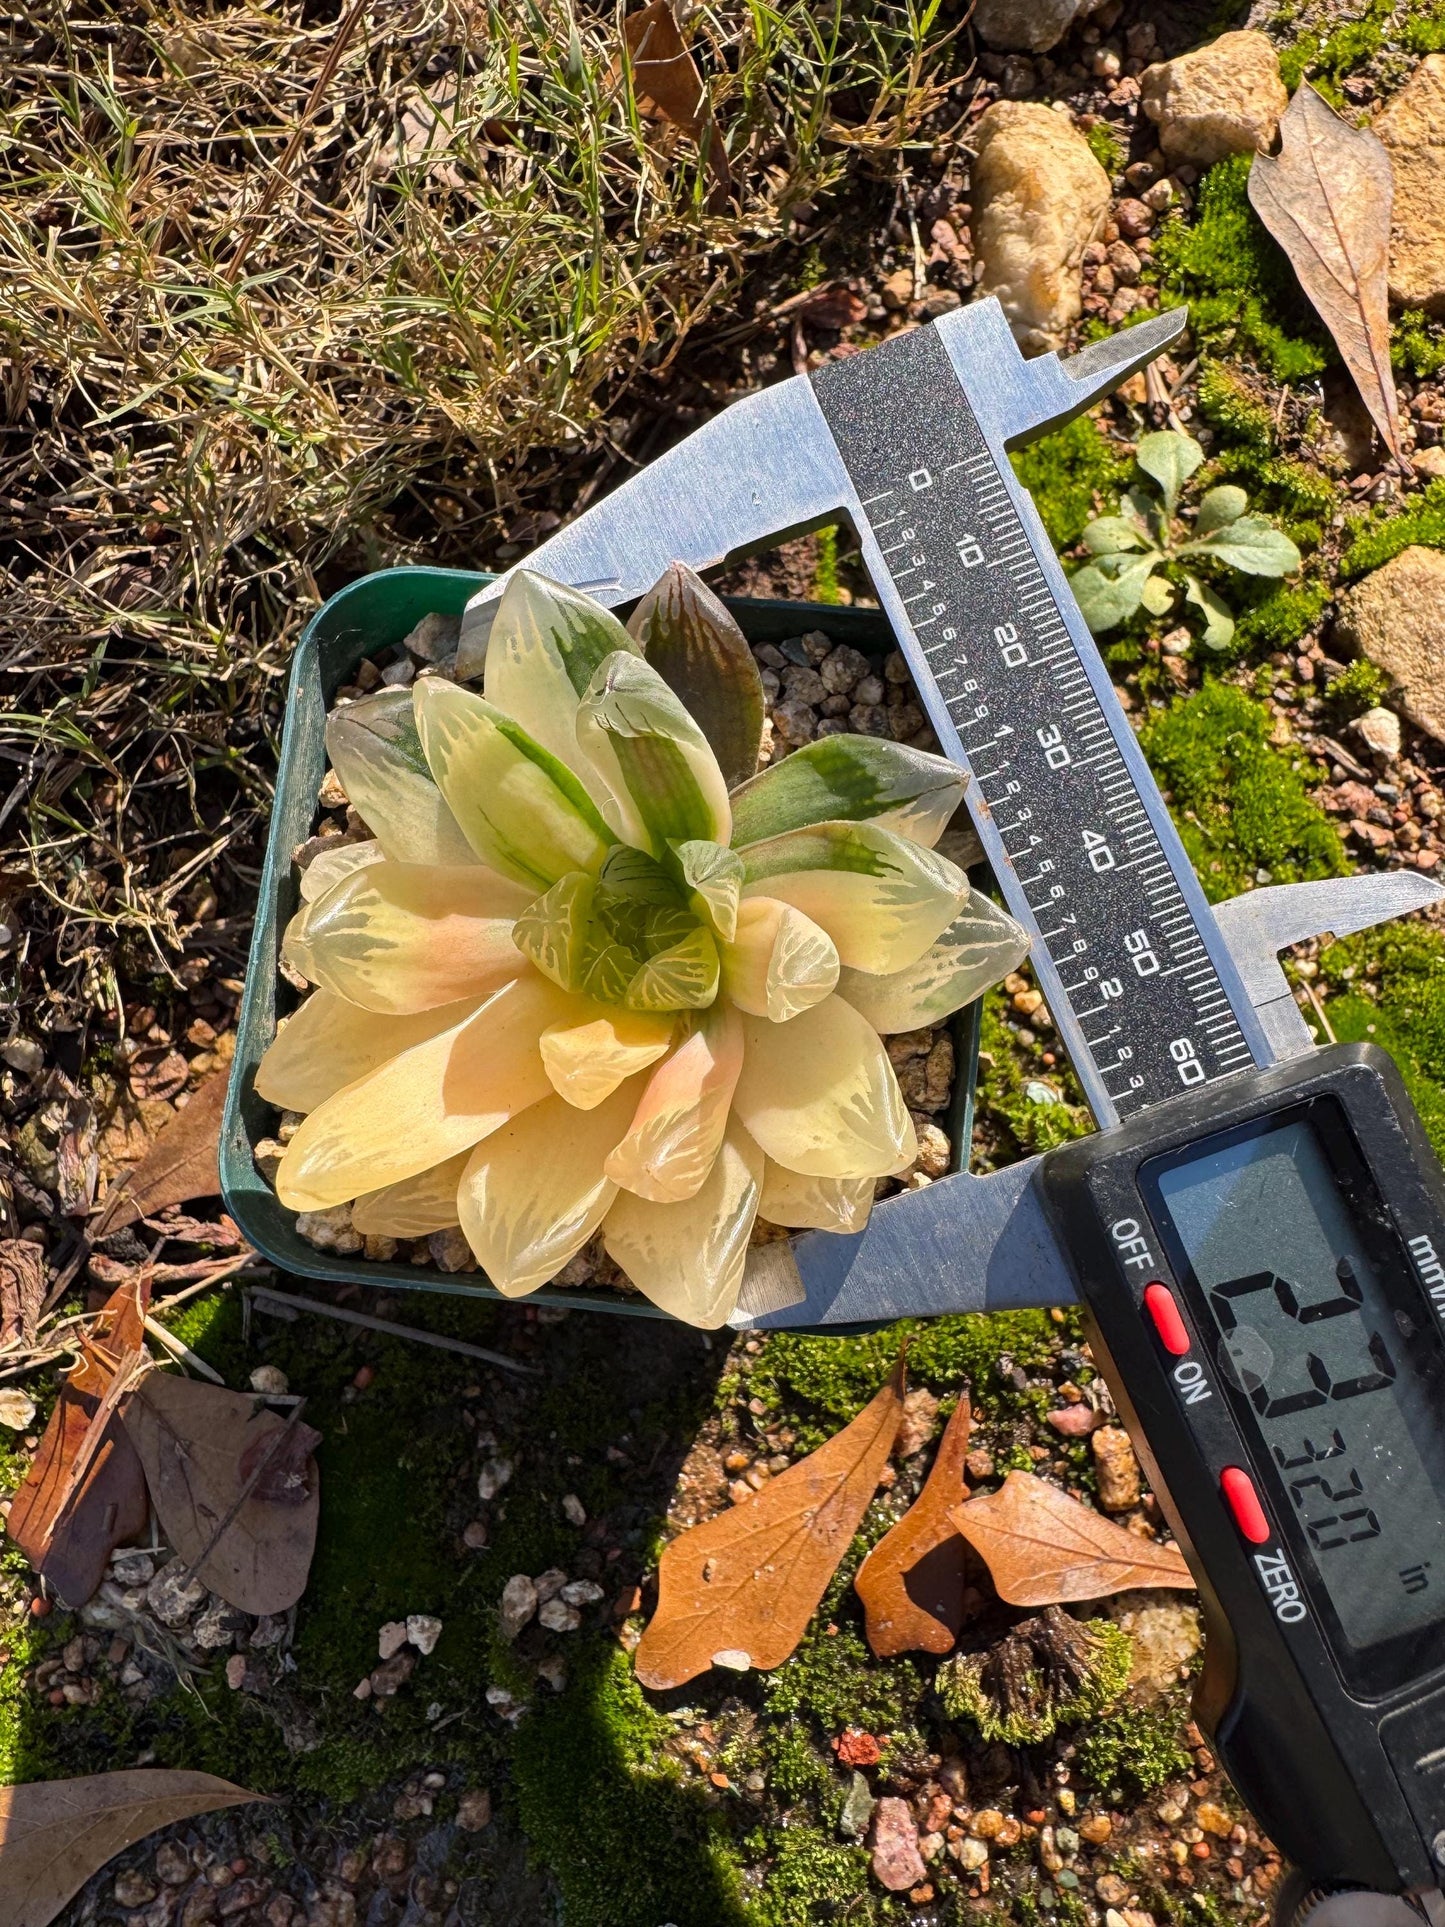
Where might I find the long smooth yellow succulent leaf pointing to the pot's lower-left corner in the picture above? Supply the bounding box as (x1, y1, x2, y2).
(276, 971, 576, 1210)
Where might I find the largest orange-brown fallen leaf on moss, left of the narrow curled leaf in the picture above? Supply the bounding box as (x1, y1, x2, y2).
(636, 1362, 904, 1690)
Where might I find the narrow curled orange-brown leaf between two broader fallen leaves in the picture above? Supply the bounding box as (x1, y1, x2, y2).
(854, 1397, 973, 1659)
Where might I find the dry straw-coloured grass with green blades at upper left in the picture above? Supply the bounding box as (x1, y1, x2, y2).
(0, 0, 952, 994)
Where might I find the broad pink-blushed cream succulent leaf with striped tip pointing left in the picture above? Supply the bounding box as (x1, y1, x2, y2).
(283, 861, 528, 1017)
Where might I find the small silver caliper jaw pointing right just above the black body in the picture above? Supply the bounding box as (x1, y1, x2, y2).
(1214, 869, 1445, 1058)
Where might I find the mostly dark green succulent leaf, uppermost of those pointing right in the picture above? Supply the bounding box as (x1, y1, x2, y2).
(732, 736, 969, 850)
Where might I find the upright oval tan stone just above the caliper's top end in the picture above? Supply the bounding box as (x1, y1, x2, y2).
(973, 100, 1110, 353)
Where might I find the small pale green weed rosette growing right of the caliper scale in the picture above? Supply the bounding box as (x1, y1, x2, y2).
(1071, 430, 1301, 649)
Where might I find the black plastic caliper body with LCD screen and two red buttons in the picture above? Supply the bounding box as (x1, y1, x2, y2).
(1042, 1044, 1445, 1890)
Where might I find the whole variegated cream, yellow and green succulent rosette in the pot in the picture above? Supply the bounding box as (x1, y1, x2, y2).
(256, 568, 1025, 1326)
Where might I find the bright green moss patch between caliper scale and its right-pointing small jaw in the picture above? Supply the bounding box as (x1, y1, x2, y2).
(1141, 682, 1351, 902)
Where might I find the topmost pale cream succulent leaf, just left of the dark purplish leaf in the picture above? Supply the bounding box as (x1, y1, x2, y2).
(483, 568, 638, 767)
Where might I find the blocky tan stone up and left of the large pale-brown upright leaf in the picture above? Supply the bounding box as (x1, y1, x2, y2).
(1139, 33, 1289, 168)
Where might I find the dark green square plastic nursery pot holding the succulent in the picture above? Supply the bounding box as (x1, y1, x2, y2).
(220, 568, 979, 1318)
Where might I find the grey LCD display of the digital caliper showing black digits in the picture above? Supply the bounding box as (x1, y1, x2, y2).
(1141, 1098, 1445, 1671)
